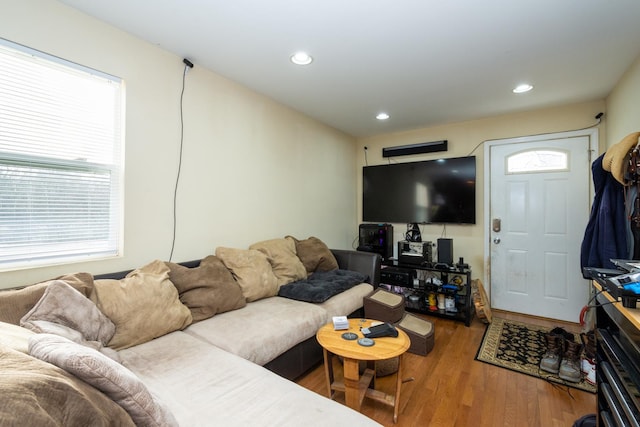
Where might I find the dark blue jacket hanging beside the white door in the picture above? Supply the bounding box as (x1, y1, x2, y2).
(580, 155, 630, 270)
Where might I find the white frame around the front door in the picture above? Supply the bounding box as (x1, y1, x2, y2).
(483, 130, 599, 307)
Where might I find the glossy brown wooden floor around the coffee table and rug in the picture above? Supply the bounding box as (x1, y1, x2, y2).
(296, 312, 596, 427)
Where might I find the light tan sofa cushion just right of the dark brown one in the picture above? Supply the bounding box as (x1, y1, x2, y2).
(216, 247, 278, 302)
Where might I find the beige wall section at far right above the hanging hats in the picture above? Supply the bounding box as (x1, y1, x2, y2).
(606, 56, 640, 146)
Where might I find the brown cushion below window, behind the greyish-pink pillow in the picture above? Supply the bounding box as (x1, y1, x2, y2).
(0, 273, 93, 325)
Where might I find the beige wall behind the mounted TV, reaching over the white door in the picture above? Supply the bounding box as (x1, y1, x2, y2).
(356, 100, 605, 279)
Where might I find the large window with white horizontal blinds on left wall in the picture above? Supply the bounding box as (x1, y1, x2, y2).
(0, 39, 124, 270)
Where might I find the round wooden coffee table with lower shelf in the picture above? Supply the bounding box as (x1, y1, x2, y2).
(316, 319, 411, 422)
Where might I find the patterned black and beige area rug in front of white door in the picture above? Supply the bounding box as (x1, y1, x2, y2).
(476, 317, 596, 393)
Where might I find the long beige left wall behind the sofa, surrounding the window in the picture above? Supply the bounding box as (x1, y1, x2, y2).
(0, 0, 357, 287)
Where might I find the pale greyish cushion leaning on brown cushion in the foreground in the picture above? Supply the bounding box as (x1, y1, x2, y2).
(29, 334, 178, 426)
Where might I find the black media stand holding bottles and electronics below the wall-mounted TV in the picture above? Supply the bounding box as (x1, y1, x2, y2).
(380, 260, 474, 326)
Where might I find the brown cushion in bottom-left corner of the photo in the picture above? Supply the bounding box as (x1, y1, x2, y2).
(0, 344, 135, 427)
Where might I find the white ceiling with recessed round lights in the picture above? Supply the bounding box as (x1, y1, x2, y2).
(61, 0, 640, 137)
